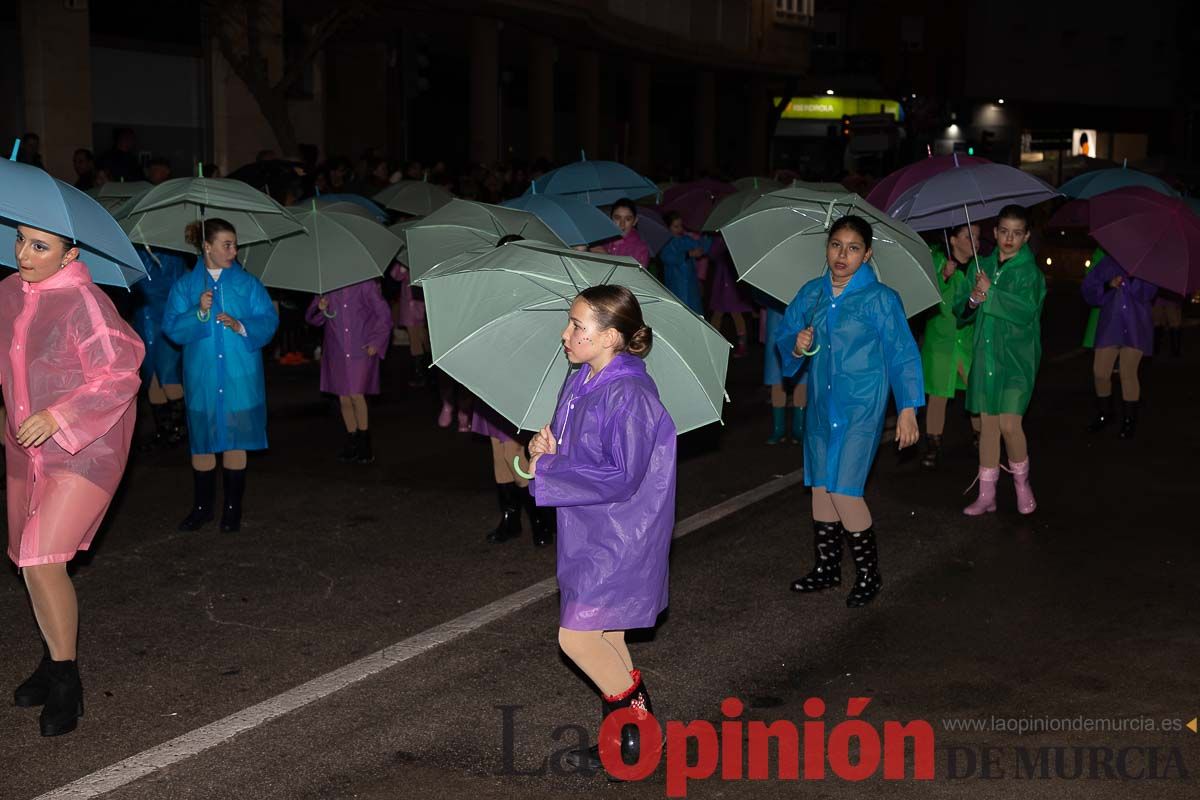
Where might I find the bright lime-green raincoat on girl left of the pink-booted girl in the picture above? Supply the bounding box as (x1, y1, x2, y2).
(920, 247, 974, 397)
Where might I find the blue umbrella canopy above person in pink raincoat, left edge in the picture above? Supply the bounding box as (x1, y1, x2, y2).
(0, 161, 145, 288)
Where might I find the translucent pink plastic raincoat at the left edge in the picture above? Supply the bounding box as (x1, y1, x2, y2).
(0, 261, 145, 567)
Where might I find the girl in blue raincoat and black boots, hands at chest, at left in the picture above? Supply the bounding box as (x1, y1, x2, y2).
(162, 218, 280, 533)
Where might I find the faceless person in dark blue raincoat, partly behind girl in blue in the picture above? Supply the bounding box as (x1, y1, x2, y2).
(131, 247, 187, 450)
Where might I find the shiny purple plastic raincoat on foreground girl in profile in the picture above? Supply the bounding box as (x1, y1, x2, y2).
(529, 353, 676, 631)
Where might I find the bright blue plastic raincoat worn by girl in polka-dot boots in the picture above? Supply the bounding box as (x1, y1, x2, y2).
(775, 264, 925, 497)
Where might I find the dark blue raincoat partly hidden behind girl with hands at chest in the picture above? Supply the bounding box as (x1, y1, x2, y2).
(131, 247, 187, 386)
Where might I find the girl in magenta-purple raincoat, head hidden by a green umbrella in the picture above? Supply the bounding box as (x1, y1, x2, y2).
(306, 281, 391, 464)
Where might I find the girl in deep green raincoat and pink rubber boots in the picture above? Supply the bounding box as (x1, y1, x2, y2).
(955, 205, 1046, 517)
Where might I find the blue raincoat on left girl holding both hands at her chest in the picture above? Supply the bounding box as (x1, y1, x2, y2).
(162, 260, 280, 453)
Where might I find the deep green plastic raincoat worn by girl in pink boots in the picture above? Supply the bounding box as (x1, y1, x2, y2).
(954, 245, 1046, 414)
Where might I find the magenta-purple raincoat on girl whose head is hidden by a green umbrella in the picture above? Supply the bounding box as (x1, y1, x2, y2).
(306, 281, 391, 397)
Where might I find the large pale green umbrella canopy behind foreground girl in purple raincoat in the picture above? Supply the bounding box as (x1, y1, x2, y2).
(421, 241, 730, 433)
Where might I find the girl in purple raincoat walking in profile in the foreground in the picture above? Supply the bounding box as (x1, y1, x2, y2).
(529, 285, 676, 769)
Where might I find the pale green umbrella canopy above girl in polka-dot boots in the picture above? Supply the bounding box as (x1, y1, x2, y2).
(721, 187, 941, 317)
